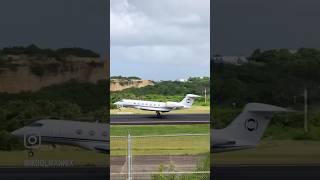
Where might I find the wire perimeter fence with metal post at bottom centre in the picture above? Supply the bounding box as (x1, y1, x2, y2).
(110, 134, 210, 180)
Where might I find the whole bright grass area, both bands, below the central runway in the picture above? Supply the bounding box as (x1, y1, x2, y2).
(110, 124, 210, 156)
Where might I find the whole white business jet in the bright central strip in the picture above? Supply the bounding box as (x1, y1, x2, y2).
(114, 94, 201, 116)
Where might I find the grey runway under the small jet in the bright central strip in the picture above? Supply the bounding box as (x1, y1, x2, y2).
(110, 114, 210, 125)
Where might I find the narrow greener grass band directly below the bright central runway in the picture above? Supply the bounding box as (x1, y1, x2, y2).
(110, 124, 210, 136)
